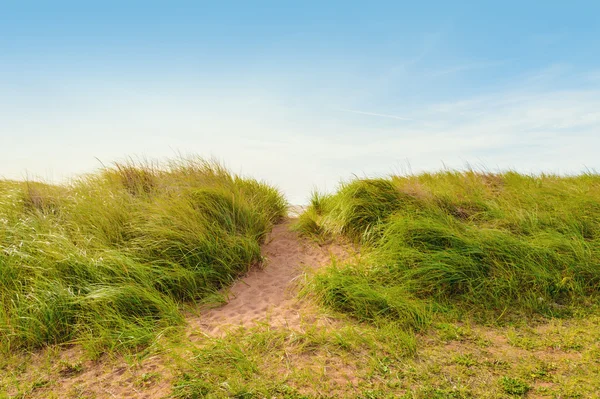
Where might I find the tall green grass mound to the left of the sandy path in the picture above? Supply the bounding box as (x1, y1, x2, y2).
(0, 160, 286, 350)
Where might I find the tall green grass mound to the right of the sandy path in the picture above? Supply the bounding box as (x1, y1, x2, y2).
(295, 172, 600, 330)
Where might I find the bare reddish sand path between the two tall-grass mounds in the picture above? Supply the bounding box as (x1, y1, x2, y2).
(188, 219, 348, 336)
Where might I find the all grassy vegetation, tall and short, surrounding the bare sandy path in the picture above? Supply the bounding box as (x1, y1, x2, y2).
(0, 165, 600, 399)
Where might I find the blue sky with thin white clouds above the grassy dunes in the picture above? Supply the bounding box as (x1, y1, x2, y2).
(0, 0, 600, 204)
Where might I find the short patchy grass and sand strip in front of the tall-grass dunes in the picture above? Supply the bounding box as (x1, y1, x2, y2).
(5, 316, 600, 399)
